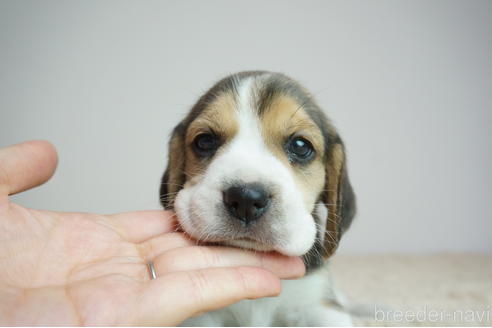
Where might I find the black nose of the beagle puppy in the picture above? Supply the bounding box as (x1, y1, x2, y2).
(224, 185, 271, 224)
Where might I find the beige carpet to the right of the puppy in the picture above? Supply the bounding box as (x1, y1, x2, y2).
(332, 254, 492, 326)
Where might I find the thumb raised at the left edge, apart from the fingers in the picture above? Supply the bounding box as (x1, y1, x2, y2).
(0, 140, 58, 196)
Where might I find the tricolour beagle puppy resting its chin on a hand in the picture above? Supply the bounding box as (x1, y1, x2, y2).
(160, 71, 355, 326)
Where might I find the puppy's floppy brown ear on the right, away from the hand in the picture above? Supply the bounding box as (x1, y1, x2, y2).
(323, 142, 356, 257)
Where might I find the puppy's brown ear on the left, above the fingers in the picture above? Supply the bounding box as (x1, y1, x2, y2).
(160, 124, 185, 210)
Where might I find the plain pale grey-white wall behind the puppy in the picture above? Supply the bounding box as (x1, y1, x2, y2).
(0, 0, 492, 252)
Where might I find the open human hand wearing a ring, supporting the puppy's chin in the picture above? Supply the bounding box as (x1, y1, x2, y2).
(0, 141, 304, 326)
